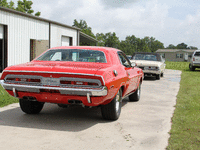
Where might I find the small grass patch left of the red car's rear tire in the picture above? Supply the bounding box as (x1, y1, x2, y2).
(0, 85, 19, 107)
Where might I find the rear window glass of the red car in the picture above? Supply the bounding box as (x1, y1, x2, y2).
(35, 49, 106, 63)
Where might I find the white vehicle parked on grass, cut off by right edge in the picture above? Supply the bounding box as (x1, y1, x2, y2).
(189, 50, 200, 71)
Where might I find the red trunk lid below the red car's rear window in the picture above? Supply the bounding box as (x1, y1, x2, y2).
(4, 61, 108, 75)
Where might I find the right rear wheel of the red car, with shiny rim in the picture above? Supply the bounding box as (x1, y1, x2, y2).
(101, 89, 122, 120)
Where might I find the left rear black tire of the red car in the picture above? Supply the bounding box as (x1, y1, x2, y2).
(19, 99, 44, 114)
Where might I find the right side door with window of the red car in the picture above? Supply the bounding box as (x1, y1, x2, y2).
(118, 52, 138, 95)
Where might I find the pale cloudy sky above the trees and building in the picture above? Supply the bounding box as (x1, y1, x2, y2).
(8, 0, 200, 49)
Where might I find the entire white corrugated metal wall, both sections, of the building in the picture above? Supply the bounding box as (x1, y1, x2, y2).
(0, 10, 77, 66)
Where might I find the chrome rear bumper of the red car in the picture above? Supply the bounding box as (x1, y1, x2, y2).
(0, 80, 107, 103)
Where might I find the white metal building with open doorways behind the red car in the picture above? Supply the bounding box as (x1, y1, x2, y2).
(0, 7, 97, 72)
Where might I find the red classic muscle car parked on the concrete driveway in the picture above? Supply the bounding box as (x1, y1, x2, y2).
(0, 46, 144, 120)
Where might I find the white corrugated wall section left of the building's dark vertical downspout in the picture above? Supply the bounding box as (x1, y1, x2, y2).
(0, 11, 49, 66)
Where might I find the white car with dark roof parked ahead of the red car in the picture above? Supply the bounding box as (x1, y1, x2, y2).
(130, 52, 166, 80)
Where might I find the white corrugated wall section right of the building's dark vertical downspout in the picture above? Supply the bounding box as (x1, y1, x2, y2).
(51, 24, 77, 47)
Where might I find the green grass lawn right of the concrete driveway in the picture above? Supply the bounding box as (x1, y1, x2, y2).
(166, 62, 200, 150)
